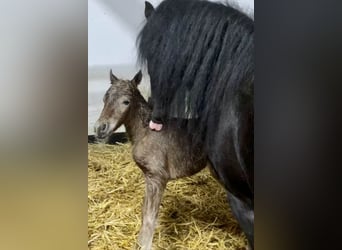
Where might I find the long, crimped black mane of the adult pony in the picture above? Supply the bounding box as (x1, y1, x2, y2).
(137, 0, 254, 139)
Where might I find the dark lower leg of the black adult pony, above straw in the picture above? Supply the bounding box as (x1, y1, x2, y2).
(228, 193, 254, 249)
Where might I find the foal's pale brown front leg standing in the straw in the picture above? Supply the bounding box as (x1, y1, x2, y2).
(138, 176, 167, 250)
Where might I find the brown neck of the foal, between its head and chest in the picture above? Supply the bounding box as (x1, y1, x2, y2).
(124, 92, 152, 144)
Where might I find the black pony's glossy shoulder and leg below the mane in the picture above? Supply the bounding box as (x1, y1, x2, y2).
(206, 100, 254, 248)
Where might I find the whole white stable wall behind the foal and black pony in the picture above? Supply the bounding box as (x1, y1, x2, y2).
(88, 0, 254, 134)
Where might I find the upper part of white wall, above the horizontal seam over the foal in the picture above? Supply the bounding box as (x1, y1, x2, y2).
(88, 0, 254, 65)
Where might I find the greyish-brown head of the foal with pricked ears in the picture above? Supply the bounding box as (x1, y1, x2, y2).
(94, 70, 142, 139)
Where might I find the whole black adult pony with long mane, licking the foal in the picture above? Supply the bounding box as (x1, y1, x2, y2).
(137, 0, 254, 248)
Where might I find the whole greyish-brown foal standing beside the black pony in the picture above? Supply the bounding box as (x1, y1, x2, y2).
(95, 71, 207, 250)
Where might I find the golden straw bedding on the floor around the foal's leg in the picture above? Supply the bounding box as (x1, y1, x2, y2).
(88, 143, 246, 250)
